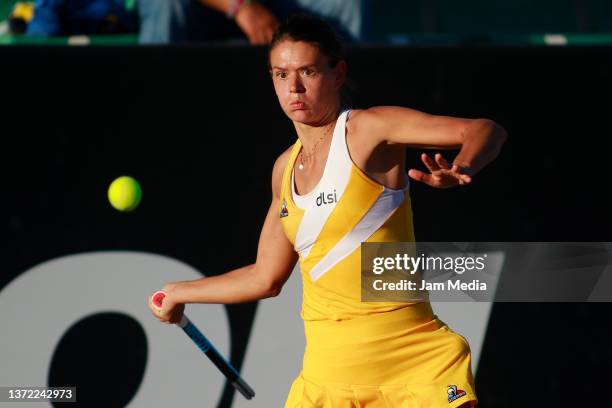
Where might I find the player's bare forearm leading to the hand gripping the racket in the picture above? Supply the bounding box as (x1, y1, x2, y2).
(164, 264, 278, 304)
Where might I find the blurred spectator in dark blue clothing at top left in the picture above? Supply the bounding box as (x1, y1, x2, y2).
(26, 0, 138, 37)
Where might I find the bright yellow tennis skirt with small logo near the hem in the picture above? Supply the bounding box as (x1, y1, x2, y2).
(285, 303, 477, 408)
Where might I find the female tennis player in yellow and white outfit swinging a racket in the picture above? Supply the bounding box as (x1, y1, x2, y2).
(151, 16, 506, 408)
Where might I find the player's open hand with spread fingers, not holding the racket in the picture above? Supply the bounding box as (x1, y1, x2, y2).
(408, 153, 472, 188)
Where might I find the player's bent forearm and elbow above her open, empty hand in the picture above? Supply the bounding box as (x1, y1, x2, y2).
(453, 119, 507, 175)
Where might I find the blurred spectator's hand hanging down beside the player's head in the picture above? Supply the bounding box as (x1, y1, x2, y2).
(235, 3, 278, 45)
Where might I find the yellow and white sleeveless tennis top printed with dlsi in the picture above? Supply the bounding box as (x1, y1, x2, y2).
(279, 111, 414, 321)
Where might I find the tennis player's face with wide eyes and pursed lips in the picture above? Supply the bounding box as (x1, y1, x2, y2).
(270, 40, 346, 125)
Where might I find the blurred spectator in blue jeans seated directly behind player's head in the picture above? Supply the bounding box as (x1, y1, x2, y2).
(138, 0, 366, 44)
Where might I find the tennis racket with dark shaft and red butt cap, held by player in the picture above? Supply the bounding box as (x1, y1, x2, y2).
(153, 290, 255, 400)
